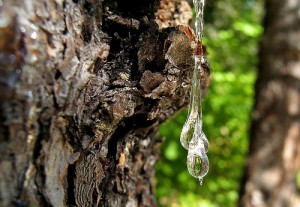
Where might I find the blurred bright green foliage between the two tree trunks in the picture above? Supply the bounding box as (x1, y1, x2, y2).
(156, 0, 263, 207)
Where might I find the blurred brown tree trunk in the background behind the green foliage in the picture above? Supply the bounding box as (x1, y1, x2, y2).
(239, 0, 300, 207)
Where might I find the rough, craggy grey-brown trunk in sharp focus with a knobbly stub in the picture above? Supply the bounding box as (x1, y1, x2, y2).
(0, 0, 206, 207)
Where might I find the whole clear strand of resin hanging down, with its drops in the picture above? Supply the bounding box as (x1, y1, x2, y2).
(180, 0, 209, 184)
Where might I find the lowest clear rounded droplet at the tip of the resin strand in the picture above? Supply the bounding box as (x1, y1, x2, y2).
(187, 150, 209, 179)
